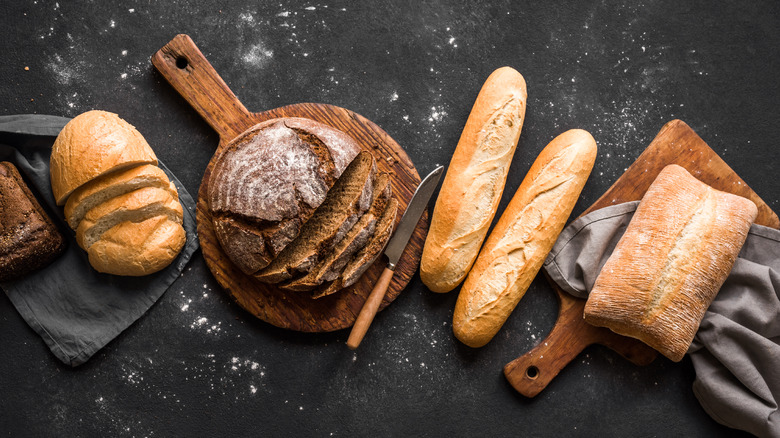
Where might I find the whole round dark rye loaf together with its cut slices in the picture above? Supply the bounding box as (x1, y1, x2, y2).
(208, 118, 398, 298)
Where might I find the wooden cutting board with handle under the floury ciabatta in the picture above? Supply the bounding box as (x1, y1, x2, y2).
(504, 120, 780, 397)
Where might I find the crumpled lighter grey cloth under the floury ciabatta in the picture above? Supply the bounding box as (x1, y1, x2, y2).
(544, 202, 780, 437)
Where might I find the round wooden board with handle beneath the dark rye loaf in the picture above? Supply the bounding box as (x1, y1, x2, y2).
(152, 35, 428, 332)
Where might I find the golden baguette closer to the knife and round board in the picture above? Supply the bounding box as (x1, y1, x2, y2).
(420, 67, 527, 292)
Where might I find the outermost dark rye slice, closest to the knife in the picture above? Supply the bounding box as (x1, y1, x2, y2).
(312, 198, 398, 298)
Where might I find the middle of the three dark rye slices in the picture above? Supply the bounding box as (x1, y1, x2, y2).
(279, 173, 392, 292)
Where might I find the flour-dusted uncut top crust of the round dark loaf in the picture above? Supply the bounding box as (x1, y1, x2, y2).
(209, 118, 360, 222)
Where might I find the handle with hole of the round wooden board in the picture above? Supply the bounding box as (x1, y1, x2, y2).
(152, 34, 252, 142)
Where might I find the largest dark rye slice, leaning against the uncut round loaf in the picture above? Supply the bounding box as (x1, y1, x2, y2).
(254, 151, 376, 283)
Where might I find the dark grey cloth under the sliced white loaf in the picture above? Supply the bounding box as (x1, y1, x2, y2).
(0, 115, 198, 366)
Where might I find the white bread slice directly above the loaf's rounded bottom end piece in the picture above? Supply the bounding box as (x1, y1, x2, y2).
(76, 183, 184, 250)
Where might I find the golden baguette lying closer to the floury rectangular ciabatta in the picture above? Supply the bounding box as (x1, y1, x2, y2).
(452, 129, 596, 347)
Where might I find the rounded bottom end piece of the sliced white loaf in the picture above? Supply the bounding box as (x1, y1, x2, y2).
(87, 216, 186, 276)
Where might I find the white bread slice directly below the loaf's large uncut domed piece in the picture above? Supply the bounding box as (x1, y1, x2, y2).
(65, 164, 179, 230)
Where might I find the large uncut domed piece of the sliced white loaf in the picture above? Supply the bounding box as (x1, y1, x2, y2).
(49, 111, 157, 205)
